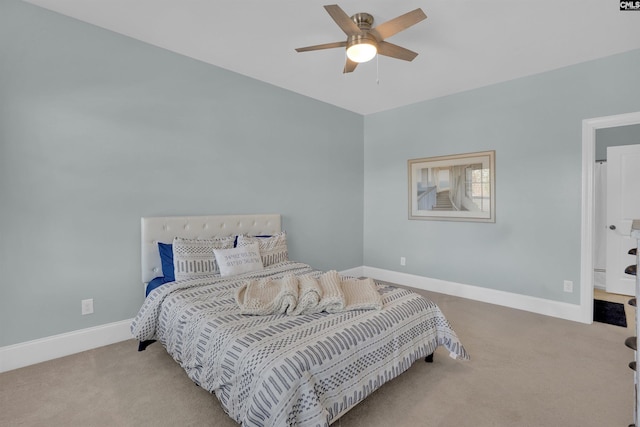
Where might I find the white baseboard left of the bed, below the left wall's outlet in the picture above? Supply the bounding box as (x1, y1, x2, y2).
(0, 319, 132, 372)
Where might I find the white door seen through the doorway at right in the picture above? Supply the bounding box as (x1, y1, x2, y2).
(606, 144, 640, 295)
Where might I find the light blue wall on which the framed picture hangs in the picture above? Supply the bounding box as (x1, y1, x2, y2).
(364, 50, 640, 304)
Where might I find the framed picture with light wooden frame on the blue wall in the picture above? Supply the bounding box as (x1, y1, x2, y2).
(408, 151, 496, 222)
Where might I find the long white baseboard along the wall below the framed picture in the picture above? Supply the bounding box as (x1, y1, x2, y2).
(353, 266, 590, 323)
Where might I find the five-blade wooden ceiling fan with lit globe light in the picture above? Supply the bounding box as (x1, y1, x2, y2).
(296, 4, 427, 73)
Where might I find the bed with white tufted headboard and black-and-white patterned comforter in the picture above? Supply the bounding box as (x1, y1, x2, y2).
(131, 214, 469, 427)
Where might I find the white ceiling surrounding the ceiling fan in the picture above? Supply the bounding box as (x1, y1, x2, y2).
(25, 0, 640, 115)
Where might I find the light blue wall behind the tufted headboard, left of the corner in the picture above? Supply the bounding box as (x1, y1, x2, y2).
(0, 0, 363, 346)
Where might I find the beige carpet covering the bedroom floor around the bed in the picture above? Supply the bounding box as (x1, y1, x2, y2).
(0, 292, 635, 427)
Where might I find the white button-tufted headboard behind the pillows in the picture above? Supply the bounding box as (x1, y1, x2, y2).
(141, 214, 281, 283)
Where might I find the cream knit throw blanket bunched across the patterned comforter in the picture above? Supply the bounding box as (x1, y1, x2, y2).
(236, 270, 382, 315)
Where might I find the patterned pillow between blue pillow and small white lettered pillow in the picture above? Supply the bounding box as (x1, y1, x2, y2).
(173, 236, 235, 280)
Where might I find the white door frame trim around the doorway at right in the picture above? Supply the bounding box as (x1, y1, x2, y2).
(580, 111, 640, 323)
